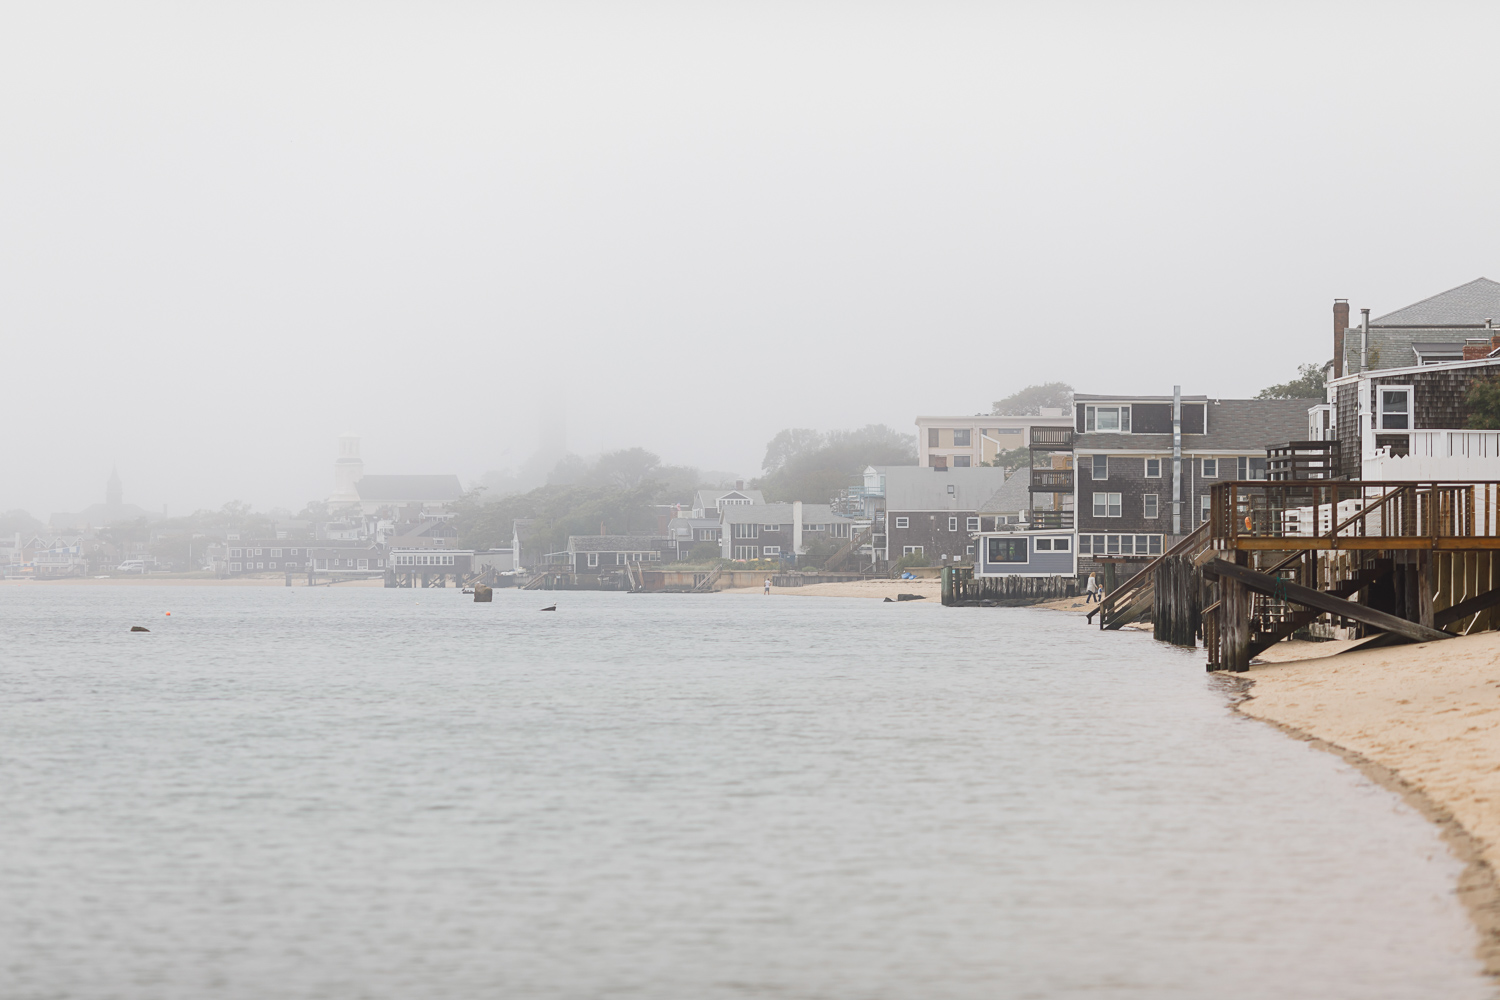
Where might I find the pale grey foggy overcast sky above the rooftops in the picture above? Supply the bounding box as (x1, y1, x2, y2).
(0, 0, 1500, 517)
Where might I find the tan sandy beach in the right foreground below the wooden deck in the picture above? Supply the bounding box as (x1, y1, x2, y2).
(1236, 633, 1500, 978)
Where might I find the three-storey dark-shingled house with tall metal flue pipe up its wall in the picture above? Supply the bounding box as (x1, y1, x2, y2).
(1073, 393, 1319, 574)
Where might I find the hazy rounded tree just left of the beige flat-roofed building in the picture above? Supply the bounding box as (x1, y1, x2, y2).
(752, 424, 917, 504)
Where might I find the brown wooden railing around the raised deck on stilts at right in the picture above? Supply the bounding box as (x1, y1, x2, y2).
(1208, 480, 1500, 550)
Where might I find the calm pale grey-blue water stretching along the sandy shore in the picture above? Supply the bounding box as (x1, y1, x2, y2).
(0, 585, 1493, 1000)
